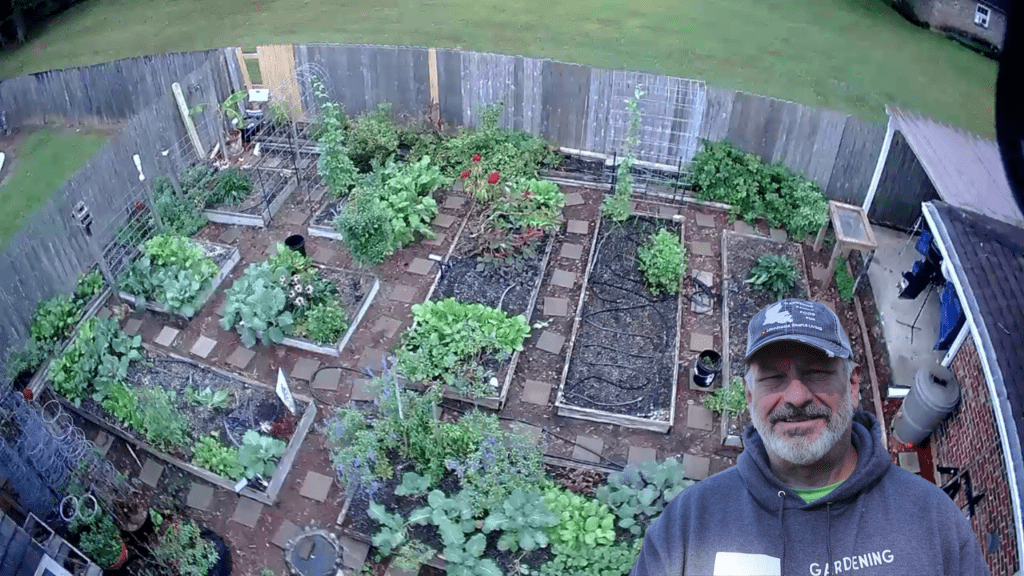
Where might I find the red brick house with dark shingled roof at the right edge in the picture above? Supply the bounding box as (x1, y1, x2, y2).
(923, 201, 1024, 575)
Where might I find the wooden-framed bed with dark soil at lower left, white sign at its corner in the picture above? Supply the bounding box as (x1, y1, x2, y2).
(53, 346, 316, 504)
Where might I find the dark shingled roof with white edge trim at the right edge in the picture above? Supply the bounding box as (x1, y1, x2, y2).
(924, 202, 1024, 561)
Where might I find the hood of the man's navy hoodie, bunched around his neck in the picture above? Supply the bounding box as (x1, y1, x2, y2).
(736, 410, 892, 510)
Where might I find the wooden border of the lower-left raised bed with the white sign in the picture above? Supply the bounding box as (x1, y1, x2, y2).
(51, 343, 316, 505)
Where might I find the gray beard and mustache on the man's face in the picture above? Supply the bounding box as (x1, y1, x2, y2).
(750, 387, 853, 465)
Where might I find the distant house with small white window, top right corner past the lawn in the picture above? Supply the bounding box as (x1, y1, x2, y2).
(892, 0, 1010, 55)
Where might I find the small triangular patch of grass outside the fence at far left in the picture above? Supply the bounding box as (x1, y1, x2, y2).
(0, 128, 108, 246)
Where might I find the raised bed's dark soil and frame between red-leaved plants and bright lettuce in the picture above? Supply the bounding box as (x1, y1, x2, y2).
(426, 206, 554, 410)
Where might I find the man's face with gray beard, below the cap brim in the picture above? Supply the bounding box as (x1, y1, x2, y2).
(746, 342, 860, 465)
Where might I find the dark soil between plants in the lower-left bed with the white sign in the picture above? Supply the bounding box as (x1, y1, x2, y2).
(73, 344, 304, 461)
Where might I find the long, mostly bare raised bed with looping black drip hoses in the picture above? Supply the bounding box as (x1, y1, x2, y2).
(555, 216, 682, 433)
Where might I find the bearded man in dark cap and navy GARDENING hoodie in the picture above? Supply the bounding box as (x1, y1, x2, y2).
(632, 299, 988, 576)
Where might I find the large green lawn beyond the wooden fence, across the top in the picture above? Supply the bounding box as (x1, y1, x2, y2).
(0, 0, 996, 136)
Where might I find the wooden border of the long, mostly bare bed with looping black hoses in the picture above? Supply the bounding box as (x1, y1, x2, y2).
(555, 212, 686, 434)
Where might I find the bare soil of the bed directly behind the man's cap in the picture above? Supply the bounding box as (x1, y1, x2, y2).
(726, 230, 810, 375)
